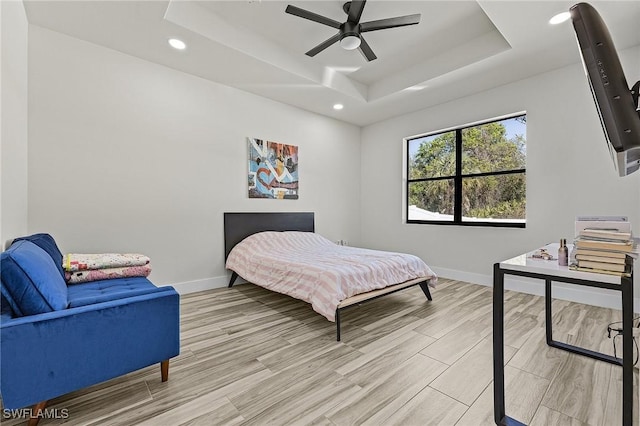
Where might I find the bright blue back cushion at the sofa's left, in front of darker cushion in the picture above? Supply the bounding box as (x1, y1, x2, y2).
(0, 240, 68, 316)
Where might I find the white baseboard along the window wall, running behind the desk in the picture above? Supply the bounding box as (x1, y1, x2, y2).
(431, 267, 640, 312)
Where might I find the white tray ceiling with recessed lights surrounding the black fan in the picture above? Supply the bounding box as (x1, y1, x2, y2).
(25, 0, 640, 126)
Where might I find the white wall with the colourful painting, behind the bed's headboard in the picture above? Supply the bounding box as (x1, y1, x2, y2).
(29, 26, 360, 290)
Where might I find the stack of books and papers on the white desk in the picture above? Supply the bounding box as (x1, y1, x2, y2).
(570, 218, 634, 275)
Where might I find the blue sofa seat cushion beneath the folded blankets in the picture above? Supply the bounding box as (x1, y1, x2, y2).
(67, 277, 172, 308)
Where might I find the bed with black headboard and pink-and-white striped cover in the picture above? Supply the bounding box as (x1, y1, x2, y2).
(224, 212, 437, 341)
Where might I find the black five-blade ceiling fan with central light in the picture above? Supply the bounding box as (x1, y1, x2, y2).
(285, 0, 420, 61)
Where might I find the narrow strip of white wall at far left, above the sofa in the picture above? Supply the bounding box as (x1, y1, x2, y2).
(0, 1, 28, 248)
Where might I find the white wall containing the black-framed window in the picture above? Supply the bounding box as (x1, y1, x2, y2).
(361, 47, 640, 305)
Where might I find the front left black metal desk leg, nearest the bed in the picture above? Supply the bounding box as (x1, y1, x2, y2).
(493, 263, 506, 425)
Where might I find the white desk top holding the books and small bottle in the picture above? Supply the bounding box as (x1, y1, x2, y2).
(500, 243, 622, 284)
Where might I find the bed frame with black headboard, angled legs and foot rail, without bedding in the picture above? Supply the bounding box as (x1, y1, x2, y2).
(224, 212, 433, 341)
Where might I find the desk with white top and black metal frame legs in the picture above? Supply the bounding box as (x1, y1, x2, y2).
(493, 244, 633, 426)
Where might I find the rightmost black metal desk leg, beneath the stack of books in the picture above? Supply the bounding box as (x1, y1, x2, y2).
(621, 276, 633, 426)
